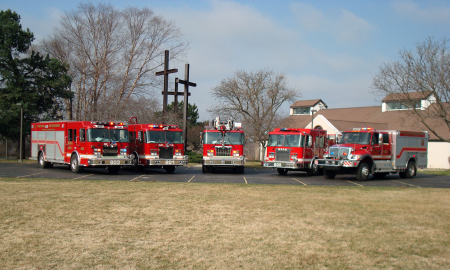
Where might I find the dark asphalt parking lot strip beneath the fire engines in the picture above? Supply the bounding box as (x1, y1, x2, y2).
(0, 162, 450, 188)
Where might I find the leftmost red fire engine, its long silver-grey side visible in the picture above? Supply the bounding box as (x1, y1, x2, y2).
(30, 121, 132, 173)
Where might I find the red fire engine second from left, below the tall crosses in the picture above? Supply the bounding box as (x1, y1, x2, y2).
(128, 117, 188, 173)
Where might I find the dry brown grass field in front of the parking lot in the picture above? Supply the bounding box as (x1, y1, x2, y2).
(0, 178, 450, 269)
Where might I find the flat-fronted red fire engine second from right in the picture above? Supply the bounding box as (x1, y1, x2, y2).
(262, 128, 328, 176)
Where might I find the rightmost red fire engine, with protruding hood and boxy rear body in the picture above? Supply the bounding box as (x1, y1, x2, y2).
(316, 128, 429, 180)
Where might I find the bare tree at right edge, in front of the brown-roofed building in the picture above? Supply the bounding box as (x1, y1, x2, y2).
(372, 37, 450, 142)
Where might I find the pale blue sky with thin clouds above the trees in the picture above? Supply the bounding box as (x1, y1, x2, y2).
(0, 0, 450, 120)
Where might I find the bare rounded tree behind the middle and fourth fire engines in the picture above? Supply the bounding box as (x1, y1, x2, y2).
(208, 70, 300, 160)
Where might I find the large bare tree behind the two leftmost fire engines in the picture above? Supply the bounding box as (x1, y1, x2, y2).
(37, 3, 187, 120)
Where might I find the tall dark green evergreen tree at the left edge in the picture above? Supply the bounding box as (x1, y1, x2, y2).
(0, 10, 73, 158)
